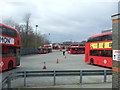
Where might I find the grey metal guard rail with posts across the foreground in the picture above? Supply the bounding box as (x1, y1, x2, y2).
(2, 70, 112, 88)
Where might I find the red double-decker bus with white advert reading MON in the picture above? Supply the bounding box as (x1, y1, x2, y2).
(0, 24, 21, 71)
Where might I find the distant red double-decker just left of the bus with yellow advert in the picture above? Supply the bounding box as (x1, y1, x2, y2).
(67, 43, 85, 54)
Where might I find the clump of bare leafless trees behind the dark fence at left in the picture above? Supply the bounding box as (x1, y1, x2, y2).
(3, 13, 49, 48)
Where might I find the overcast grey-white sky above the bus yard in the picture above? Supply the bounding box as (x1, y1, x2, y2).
(0, 0, 119, 42)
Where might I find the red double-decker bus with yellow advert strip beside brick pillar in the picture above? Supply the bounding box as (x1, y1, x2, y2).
(84, 32, 112, 67)
